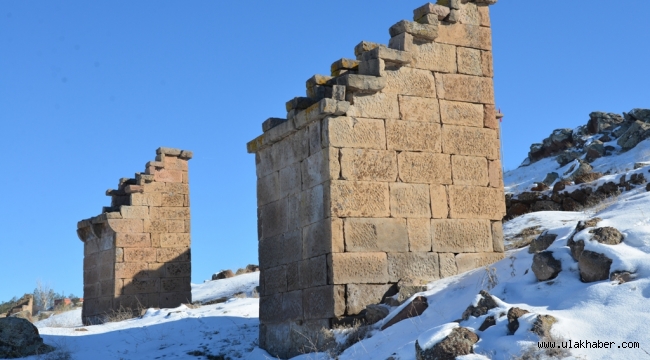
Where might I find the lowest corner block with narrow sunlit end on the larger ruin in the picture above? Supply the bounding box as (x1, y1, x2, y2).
(302, 285, 345, 320)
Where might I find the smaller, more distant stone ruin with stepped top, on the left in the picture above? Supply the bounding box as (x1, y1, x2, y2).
(77, 147, 192, 324)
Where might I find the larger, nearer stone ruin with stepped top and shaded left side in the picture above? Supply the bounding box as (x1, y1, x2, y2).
(248, 0, 505, 357)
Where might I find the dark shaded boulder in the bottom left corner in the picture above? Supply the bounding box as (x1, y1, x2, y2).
(0, 317, 54, 359)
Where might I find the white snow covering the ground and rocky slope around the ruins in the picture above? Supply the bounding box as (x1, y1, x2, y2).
(12, 147, 650, 360)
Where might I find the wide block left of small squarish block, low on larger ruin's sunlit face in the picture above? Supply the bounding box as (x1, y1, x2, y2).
(388, 252, 440, 282)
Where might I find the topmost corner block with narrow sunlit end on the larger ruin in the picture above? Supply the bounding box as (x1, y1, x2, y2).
(302, 148, 340, 190)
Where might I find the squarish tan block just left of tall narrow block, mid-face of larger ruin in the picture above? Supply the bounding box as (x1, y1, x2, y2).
(390, 183, 431, 218)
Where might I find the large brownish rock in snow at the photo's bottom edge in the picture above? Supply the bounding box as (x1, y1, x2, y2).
(415, 327, 479, 360)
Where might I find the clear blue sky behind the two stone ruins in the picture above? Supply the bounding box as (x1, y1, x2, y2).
(0, 0, 650, 301)
